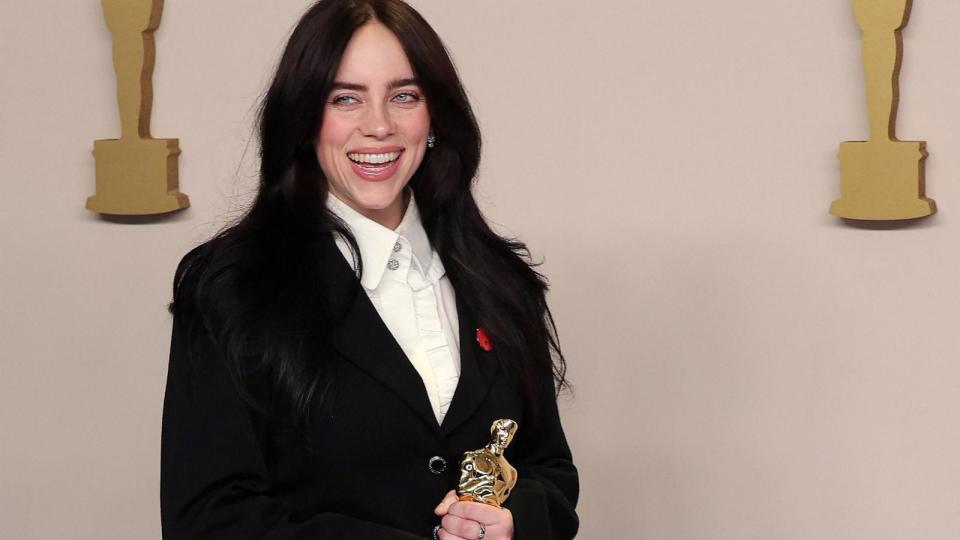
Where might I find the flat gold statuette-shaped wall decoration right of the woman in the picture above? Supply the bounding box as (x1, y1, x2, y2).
(830, 0, 937, 220)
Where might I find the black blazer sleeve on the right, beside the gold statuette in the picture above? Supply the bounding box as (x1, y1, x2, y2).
(504, 377, 580, 540)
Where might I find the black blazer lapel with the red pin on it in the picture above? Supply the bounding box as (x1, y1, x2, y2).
(440, 302, 497, 435)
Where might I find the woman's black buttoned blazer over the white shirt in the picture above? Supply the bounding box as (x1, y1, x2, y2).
(160, 241, 579, 540)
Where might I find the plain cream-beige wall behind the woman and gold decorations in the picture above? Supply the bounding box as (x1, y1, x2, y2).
(0, 0, 960, 540)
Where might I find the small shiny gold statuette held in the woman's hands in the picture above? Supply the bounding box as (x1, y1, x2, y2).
(457, 418, 517, 507)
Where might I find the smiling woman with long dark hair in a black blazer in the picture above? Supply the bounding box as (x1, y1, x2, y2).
(161, 0, 578, 540)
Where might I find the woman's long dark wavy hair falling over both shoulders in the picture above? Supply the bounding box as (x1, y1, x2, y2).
(171, 0, 566, 423)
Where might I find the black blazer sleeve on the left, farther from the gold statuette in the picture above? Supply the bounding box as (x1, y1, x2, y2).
(160, 317, 423, 540)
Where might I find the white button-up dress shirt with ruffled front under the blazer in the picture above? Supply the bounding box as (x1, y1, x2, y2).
(327, 193, 460, 422)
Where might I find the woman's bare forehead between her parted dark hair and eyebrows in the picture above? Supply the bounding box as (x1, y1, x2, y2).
(337, 21, 413, 84)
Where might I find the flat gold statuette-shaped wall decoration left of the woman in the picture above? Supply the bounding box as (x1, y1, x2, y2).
(87, 0, 190, 215)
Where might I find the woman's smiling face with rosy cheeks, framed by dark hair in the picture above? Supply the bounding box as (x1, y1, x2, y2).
(317, 22, 430, 229)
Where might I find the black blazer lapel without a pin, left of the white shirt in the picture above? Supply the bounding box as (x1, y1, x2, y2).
(323, 234, 440, 430)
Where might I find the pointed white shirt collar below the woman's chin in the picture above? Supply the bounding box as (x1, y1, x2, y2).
(327, 193, 439, 290)
